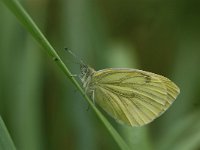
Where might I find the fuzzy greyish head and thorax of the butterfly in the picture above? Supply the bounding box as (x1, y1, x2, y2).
(79, 64, 95, 92)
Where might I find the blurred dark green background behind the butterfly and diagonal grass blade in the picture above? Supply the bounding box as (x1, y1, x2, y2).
(0, 0, 200, 150)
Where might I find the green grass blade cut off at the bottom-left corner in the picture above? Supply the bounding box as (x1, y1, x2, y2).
(0, 116, 16, 150)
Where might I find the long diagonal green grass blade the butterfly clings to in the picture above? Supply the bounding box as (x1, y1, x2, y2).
(2, 0, 129, 150)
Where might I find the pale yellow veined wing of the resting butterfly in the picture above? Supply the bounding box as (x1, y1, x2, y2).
(91, 68, 180, 126)
